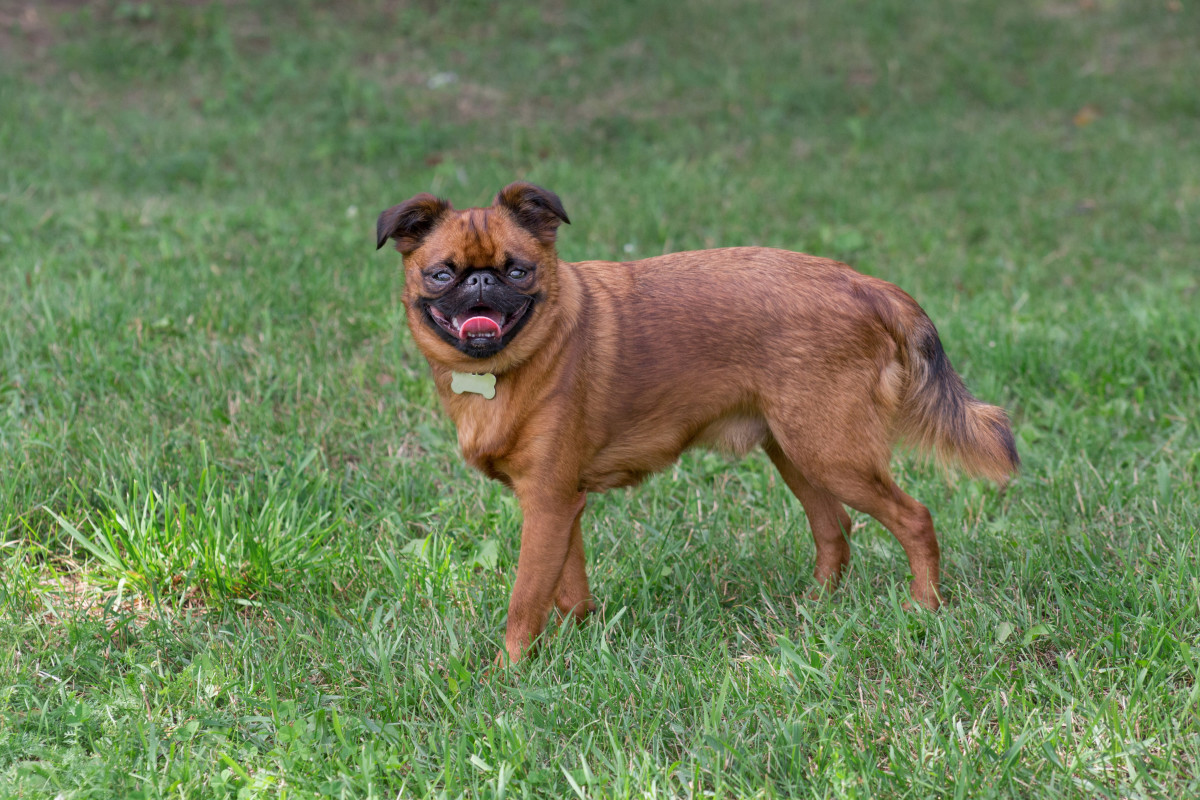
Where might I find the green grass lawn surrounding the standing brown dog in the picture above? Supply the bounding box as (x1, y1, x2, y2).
(0, 0, 1200, 798)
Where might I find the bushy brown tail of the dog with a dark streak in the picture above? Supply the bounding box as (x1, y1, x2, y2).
(886, 295, 1020, 486)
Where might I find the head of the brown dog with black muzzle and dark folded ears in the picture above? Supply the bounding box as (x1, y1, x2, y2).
(377, 184, 569, 366)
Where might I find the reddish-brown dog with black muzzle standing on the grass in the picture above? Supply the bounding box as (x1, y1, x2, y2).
(377, 184, 1018, 661)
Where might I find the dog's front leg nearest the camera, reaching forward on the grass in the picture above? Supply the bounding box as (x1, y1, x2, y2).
(500, 486, 587, 663)
